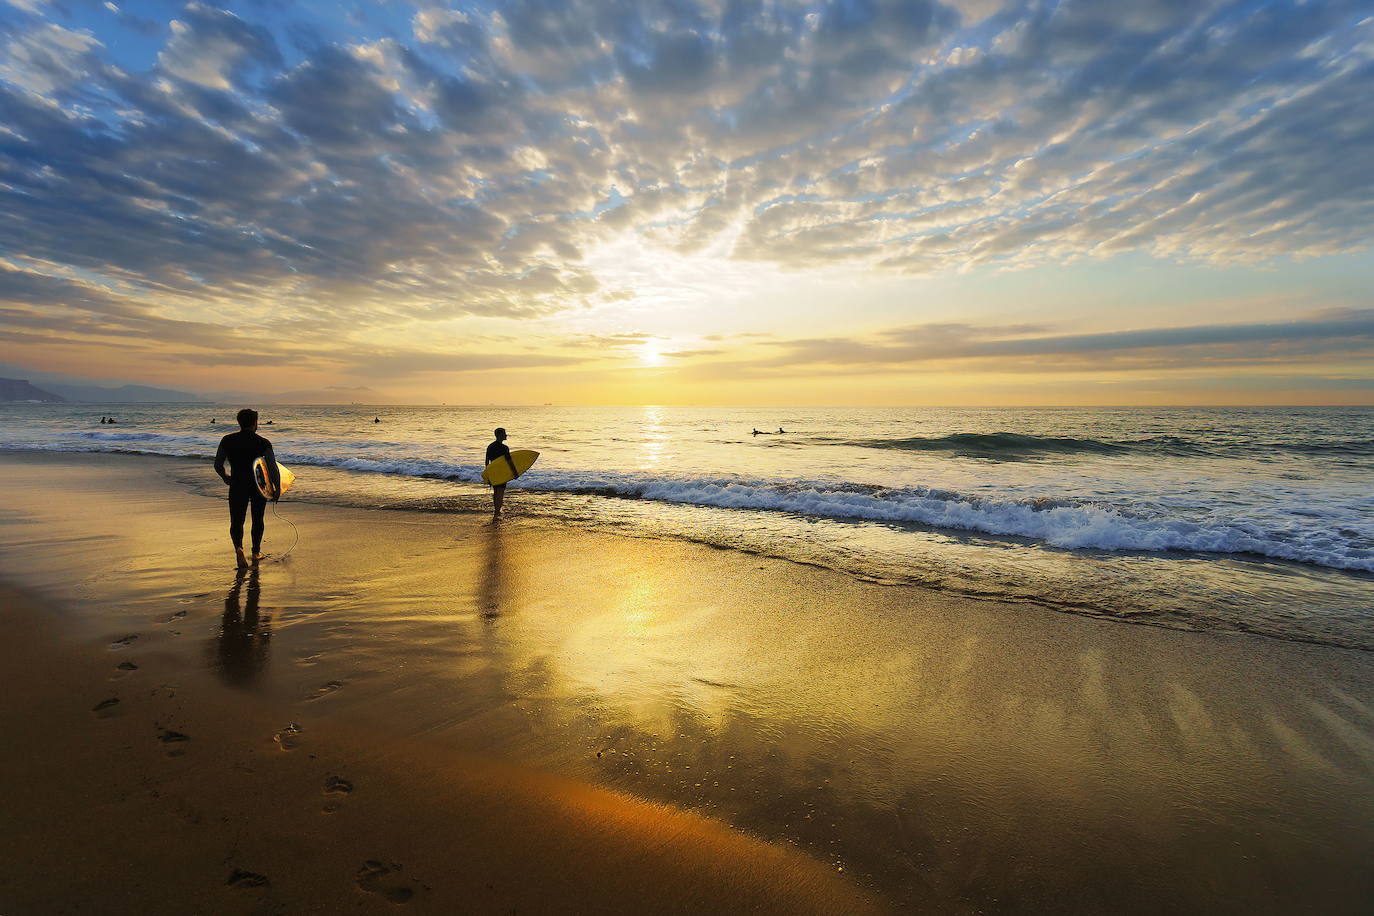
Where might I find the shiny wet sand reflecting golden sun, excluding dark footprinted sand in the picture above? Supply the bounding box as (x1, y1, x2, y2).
(0, 453, 1374, 912)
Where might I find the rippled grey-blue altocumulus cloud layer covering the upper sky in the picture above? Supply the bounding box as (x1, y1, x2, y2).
(0, 0, 1374, 372)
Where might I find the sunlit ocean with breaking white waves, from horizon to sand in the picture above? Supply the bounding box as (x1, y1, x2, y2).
(0, 404, 1374, 650)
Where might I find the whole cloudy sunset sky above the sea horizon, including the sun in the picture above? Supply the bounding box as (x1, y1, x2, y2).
(0, 0, 1374, 405)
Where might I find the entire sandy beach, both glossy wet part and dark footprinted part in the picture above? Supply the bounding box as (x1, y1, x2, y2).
(0, 453, 1374, 913)
